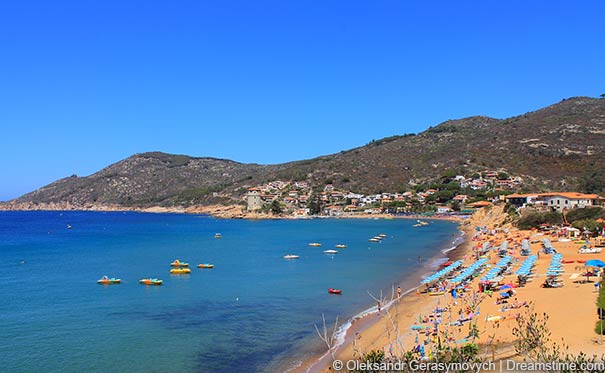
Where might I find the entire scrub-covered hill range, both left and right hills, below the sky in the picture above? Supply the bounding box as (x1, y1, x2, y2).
(8, 97, 605, 207)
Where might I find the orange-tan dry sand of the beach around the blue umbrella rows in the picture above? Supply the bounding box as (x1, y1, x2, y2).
(297, 206, 605, 372)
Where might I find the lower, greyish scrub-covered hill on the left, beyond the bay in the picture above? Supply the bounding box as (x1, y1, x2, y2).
(15, 152, 280, 206)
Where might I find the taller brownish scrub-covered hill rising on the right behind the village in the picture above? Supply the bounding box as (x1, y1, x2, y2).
(295, 97, 605, 191)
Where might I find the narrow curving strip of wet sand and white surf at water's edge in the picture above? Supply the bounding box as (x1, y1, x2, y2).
(285, 216, 472, 373)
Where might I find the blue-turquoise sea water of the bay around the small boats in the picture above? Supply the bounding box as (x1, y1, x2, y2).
(0, 212, 457, 372)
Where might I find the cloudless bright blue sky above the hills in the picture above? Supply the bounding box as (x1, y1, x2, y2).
(0, 0, 605, 200)
